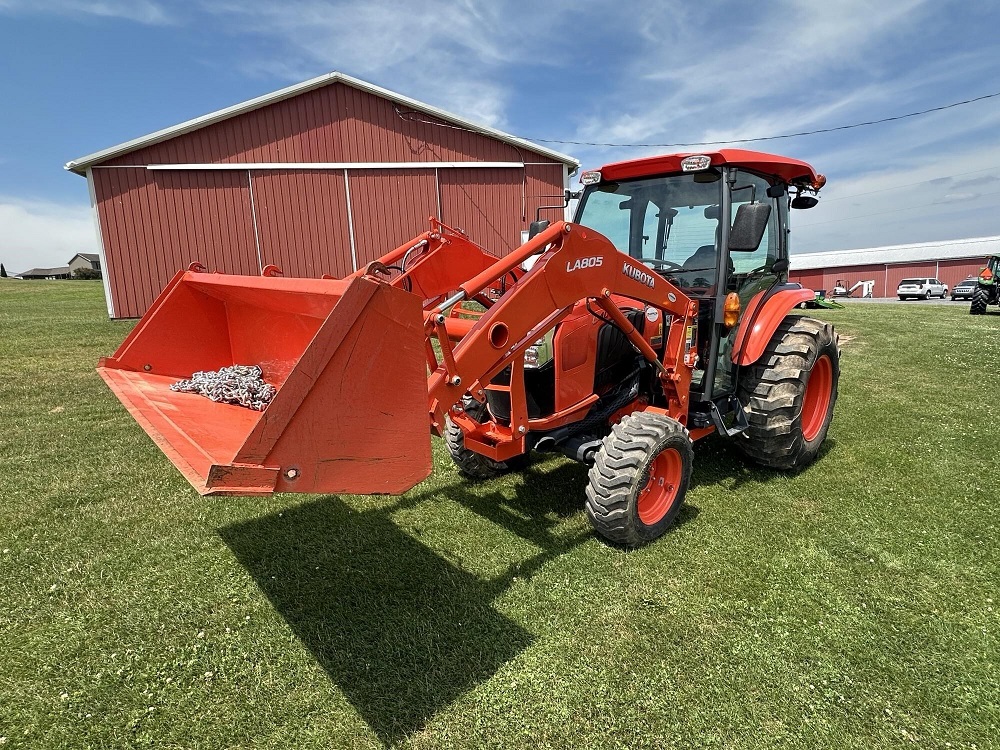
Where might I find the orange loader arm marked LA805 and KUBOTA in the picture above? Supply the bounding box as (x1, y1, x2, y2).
(425, 222, 697, 460)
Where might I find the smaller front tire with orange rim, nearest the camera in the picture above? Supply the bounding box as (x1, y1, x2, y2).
(586, 412, 694, 548)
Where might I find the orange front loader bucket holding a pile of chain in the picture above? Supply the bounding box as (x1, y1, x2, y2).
(97, 271, 431, 495)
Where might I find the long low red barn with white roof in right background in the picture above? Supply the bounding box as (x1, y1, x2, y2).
(789, 237, 1000, 297)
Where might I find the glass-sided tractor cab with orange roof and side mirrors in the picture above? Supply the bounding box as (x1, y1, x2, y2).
(575, 149, 824, 401)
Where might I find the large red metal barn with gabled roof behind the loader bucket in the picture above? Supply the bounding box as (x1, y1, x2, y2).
(66, 73, 579, 318)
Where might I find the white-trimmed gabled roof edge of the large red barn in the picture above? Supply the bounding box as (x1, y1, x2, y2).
(65, 71, 580, 175)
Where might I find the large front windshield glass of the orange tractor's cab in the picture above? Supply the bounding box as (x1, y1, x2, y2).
(576, 173, 723, 291)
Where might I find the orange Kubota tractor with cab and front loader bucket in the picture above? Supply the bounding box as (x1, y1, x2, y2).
(98, 149, 840, 547)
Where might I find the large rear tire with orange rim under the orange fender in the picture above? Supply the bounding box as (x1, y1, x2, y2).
(736, 317, 840, 471)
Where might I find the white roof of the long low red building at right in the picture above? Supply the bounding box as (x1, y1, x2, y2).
(791, 237, 1000, 271)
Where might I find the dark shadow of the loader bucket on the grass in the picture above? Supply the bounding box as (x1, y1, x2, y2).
(219, 497, 533, 745)
